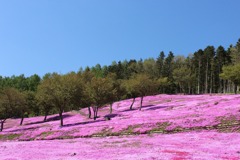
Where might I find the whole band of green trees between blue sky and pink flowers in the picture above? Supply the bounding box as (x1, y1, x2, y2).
(0, 40, 240, 131)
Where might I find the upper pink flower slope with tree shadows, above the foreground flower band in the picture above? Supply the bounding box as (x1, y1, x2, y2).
(0, 95, 240, 140)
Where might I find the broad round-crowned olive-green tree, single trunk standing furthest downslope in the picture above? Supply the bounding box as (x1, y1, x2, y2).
(36, 73, 83, 126)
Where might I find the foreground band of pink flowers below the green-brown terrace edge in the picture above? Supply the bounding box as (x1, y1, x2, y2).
(0, 131, 240, 160)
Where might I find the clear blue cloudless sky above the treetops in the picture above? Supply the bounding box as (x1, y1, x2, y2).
(0, 0, 240, 76)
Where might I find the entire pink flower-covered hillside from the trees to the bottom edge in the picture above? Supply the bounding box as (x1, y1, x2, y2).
(0, 94, 240, 160)
